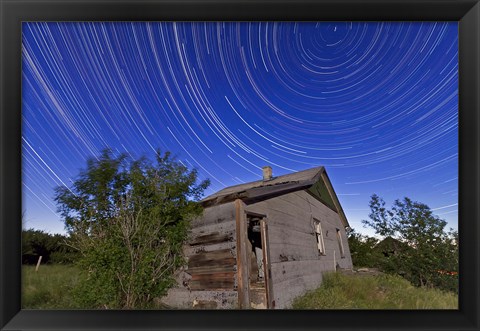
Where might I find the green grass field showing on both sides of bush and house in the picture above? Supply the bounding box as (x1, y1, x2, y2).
(22, 265, 458, 309)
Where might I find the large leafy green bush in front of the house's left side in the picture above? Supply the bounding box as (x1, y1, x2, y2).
(55, 150, 209, 308)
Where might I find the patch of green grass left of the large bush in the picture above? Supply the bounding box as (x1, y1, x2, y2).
(22, 264, 81, 309)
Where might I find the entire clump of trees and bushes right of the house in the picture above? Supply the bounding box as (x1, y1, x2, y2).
(348, 195, 459, 293)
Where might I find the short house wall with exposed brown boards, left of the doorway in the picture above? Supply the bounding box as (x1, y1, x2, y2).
(162, 202, 238, 309)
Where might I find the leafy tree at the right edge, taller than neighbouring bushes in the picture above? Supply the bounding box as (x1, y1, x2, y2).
(362, 194, 458, 291)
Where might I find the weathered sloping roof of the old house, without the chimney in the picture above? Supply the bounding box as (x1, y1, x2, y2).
(201, 167, 349, 227)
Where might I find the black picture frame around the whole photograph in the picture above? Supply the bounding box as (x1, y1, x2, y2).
(0, 0, 480, 330)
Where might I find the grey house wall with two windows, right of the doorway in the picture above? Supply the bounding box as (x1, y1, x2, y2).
(245, 191, 352, 309)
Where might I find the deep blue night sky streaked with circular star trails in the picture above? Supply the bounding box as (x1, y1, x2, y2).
(22, 22, 458, 234)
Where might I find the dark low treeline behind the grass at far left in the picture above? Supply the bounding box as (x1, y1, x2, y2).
(22, 229, 78, 264)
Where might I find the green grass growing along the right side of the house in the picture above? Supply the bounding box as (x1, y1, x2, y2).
(292, 273, 458, 309)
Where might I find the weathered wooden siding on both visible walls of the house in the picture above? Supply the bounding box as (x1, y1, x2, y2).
(163, 187, 352, 309)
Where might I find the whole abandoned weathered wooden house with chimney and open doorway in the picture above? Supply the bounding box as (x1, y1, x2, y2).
(163, 167, 352, 309)
